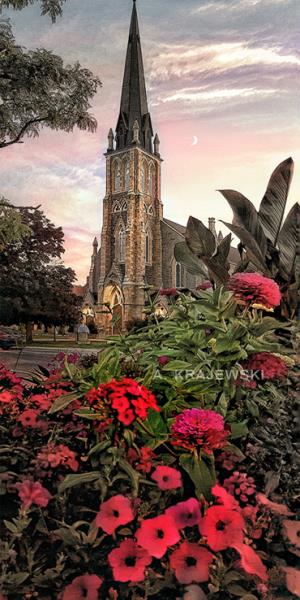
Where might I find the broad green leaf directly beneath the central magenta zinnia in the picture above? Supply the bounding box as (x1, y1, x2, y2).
(179, 454, 216, 500)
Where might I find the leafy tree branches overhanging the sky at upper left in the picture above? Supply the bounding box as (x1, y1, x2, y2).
(0, 20, 101, 148)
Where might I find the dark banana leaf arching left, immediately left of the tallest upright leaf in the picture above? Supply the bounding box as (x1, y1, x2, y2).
(219, 190, 268, 259)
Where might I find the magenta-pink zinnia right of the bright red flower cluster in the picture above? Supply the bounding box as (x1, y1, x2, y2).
(171, 408, 230, 454)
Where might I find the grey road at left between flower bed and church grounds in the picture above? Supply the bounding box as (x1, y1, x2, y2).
(0, 348, 97, 376)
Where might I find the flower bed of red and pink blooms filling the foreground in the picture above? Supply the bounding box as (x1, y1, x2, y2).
(0, 282, 300, 600)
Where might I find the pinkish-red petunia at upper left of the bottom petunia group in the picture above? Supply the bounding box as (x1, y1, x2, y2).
(96, 494, 134, 534)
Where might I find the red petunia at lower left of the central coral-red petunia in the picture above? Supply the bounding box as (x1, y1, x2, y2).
(108, 539, 152, 582)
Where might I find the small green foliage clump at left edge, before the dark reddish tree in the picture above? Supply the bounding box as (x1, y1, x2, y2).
(0, 197, 30, 252)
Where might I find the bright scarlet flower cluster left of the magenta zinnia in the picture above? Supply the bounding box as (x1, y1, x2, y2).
(86, 377, 159, 426)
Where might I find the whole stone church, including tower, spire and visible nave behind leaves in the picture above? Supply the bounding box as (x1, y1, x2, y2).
(83, 0, 234, 333)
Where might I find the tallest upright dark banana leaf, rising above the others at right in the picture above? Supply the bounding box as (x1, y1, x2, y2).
(258, 158, 294, 246)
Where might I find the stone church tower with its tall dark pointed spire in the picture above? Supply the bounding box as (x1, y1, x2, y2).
(97, 1, 163, 328)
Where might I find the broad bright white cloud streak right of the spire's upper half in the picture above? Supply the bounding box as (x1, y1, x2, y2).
(150, 42, 300, 82)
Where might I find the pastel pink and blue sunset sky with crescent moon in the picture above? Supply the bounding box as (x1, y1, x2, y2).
(0, 0, 300, 284)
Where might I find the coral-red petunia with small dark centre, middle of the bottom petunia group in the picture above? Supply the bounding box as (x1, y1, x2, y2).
(136, 514, 180, 558)
